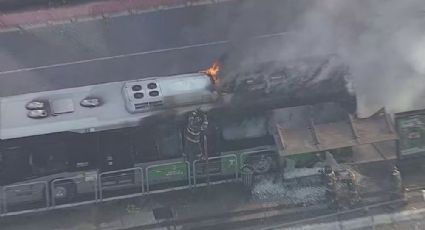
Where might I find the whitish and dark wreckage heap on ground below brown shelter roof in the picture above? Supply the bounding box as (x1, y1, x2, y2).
(251, 153, 386, 209)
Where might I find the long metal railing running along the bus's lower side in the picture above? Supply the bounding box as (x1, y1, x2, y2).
(0, 154, 243, 217)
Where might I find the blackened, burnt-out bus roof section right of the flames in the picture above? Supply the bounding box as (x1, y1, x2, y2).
(214, 55, 357, 113)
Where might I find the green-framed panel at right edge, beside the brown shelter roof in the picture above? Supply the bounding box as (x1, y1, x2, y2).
(396, 113, 425, 158)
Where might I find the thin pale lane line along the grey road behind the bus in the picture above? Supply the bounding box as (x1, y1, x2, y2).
(0, 32, 289, 75)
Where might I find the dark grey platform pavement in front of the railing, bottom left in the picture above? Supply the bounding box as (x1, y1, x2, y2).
(0, 180, 323, 230)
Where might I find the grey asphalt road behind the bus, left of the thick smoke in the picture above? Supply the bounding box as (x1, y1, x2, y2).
(0, 0, 311, 96)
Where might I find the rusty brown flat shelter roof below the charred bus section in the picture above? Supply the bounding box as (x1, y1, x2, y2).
(275, 107, 398, 156)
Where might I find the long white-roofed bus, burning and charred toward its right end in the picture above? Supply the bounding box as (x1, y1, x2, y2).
(0, 54, 362, 211)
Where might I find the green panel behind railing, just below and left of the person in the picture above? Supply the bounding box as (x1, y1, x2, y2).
(147, 162, 188, 184)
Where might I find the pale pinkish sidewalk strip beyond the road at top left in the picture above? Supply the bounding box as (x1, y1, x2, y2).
(0, 0, 234, 32)
